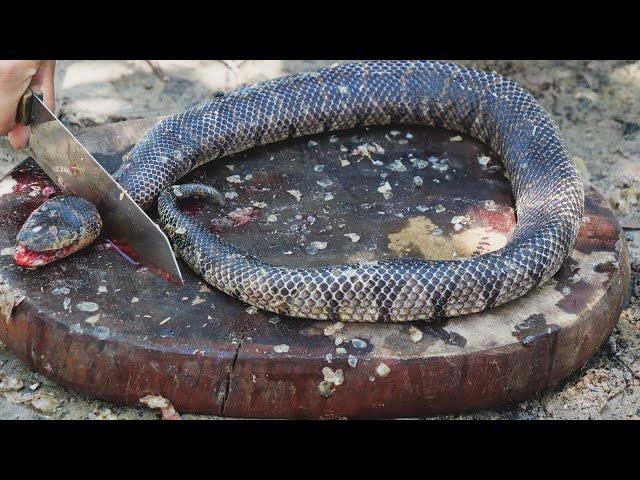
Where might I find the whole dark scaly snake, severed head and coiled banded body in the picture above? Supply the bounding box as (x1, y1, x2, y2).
(14, 60, 584, 322)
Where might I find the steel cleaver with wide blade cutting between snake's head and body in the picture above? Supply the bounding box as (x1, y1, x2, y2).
(16, 88, 183, 284)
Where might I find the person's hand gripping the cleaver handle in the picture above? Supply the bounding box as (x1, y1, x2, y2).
(0, 60, 56, 150)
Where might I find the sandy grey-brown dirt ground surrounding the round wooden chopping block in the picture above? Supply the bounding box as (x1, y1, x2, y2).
(0, 61, 640, 419)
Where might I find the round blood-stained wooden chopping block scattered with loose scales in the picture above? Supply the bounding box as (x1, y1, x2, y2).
(0, 119, 629, 418)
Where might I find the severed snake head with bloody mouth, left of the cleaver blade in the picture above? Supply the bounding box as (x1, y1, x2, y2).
(13, 195, 102, 268)
